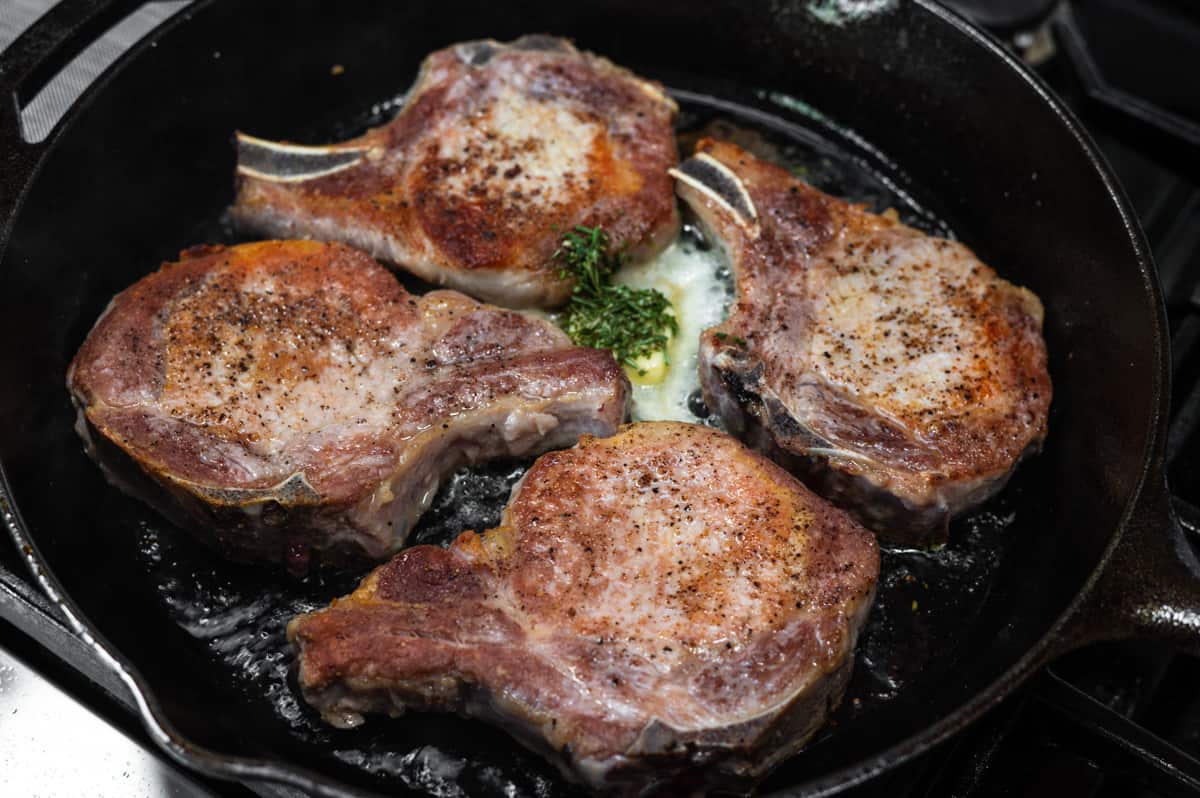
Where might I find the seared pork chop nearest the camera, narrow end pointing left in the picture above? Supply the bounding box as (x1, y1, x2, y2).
(288, 421, 878, 794)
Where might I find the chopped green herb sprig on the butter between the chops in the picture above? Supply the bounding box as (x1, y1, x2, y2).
(554, 226, 679, 373)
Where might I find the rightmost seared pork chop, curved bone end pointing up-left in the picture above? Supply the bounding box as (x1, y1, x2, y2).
(676, 140, 1050, 545)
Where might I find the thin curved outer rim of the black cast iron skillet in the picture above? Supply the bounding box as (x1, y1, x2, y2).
(0, 0, 1170, 798)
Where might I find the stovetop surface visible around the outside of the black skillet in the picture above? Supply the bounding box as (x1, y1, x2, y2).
(0, 0, 1200, 798)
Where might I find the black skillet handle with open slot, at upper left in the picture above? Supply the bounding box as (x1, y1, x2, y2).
(0, 0, 144, 240)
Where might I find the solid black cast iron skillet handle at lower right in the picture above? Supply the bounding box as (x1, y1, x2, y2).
(1057, 466, 1200, 656)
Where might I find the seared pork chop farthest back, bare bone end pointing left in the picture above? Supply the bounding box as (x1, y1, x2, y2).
(233, 36, 678, 307)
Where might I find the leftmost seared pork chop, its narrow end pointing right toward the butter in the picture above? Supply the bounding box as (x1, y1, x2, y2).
(67, 241, 629, 571)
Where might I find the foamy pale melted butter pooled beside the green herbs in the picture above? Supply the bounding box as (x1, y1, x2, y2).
(616, 233, 733, 422)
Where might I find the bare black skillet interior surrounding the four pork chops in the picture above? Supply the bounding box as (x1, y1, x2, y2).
(0, 1, 1156, 792)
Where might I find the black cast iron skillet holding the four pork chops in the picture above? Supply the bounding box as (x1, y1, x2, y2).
(0, 0, 1200, 796)
